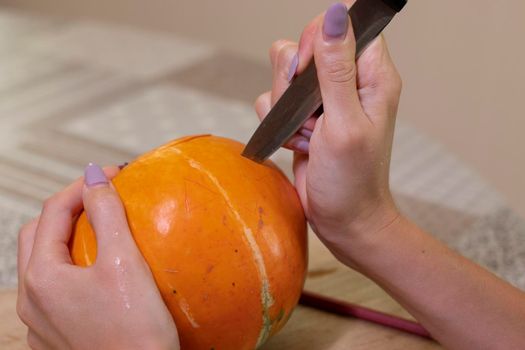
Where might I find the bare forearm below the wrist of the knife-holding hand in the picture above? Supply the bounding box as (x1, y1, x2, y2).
(346, 217, 525, 349)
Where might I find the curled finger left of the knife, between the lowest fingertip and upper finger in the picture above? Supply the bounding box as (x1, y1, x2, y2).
(272, 40, 299, 106)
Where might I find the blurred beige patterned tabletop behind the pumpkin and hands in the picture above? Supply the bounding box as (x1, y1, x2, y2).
(0, 10, 525, 289)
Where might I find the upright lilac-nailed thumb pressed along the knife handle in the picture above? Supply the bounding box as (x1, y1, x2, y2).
(314, 3, 364, 127)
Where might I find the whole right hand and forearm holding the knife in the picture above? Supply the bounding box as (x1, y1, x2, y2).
(256, 4, 525, 349)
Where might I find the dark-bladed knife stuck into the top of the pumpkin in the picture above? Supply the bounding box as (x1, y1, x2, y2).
(242, 0, 407, 163)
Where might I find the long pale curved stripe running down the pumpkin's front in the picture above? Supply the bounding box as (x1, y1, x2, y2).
(171, 148, 274, 348)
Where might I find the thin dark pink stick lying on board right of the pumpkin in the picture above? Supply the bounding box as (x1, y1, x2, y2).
(299, 291, 432, 339)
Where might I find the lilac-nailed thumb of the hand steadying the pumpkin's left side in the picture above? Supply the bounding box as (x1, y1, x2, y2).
(82, 163, 138, 264)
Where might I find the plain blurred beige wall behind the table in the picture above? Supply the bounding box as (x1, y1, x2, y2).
(0, 0, 525, 217)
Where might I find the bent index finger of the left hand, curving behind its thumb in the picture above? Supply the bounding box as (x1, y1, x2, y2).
(31, 167, 119, 264)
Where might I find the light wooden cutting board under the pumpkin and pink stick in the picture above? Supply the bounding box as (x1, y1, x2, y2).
(0, 232, 442, 350)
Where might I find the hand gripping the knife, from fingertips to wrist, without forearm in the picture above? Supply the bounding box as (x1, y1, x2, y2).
(255, 3, 401, 264)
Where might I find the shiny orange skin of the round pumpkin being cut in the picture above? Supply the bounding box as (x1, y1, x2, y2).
(70, 135, 307, 350)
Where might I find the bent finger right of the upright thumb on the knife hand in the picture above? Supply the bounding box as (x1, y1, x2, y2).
(357, 35, 402, 123)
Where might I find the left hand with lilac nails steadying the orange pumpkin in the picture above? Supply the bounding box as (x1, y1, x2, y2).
(17, 165, 179, 349)
